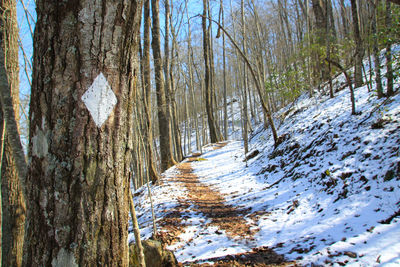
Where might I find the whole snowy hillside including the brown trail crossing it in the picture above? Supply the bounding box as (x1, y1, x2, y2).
(132, 56, 400, 266)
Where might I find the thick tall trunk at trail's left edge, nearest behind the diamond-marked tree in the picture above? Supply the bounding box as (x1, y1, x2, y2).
(151, 0, 176, 171)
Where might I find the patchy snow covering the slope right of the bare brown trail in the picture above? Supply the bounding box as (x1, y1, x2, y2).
(195, 84, 400, 266)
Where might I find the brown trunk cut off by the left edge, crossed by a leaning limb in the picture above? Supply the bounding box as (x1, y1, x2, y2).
(0, 0, 25, 266)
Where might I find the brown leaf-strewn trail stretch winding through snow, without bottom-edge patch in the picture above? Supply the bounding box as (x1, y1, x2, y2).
(161, 143, 258, 244)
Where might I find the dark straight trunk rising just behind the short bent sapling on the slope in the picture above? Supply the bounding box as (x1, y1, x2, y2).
(350, 0, 364, 88)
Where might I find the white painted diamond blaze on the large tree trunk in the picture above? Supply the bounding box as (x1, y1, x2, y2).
(81, 73, 117, 127)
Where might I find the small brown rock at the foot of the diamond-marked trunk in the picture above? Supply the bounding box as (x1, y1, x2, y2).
(129, 239, 178, 267)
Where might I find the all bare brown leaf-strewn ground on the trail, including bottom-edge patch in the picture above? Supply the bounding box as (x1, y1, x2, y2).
(159, 143, 293, 266)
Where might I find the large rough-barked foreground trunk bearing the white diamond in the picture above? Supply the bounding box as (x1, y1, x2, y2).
(24, 0, 142, 266)
